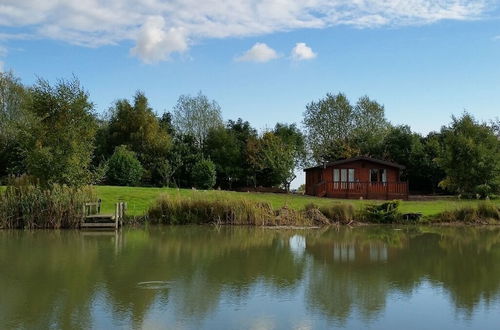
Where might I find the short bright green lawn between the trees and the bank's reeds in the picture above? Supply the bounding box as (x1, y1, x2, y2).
(91, 186, 500, 216)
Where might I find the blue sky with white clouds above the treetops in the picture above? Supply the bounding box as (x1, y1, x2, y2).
(0, 0, 500, 186)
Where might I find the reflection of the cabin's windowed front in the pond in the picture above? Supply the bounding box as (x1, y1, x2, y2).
(333, 243, 387, 262)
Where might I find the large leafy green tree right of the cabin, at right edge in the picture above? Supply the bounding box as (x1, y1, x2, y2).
(438, 113, 500, 197)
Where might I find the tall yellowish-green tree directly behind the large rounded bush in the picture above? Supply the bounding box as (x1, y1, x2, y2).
(103, 91, 172, 185)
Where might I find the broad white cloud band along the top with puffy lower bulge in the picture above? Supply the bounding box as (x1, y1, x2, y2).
(0, 0, 492, 62)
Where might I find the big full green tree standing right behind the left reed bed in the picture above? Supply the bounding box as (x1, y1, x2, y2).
(26, 78, 97, 186)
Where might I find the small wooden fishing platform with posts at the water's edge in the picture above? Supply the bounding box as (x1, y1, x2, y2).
(80, 200, 127, 229)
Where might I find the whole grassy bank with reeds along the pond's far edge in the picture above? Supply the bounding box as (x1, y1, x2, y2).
(0, 186, 500, 228)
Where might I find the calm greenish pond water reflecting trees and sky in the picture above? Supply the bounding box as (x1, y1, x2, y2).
(0, 227, 500, 329)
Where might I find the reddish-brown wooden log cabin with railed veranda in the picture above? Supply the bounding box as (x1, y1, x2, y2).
(304, 156, 408, 200)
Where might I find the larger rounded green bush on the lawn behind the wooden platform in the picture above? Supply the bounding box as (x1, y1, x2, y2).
(107, 146, 144, 186)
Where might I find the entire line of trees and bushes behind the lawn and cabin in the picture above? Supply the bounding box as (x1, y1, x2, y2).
(0, 73, 500, 196)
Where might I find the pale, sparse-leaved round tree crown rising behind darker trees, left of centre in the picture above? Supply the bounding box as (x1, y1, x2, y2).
(174, 92, 223, 149)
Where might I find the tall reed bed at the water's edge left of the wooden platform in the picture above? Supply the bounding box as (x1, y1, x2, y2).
(0, 178, 96, 229)
